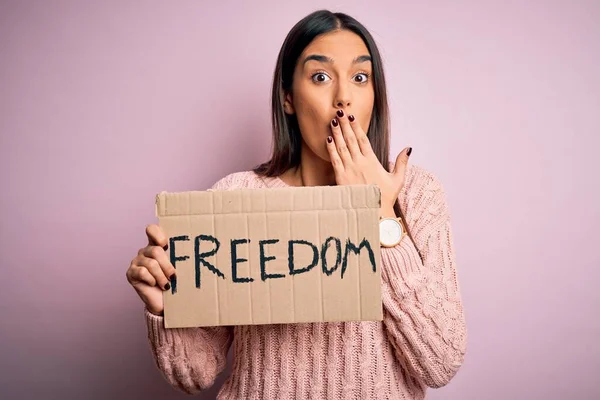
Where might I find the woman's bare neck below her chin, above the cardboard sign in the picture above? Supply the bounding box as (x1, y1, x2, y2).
(281, 142, 336, 186)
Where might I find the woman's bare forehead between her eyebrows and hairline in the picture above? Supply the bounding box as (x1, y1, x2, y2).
(302, 30, 370, 64)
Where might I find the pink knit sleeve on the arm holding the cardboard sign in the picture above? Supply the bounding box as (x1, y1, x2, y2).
(144, 174, 244, 394)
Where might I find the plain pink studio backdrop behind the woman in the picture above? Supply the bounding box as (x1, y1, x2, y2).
(0, 0, 600, 400)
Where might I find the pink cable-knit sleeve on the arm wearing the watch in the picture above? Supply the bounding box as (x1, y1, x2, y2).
(381, 167, 467, 388)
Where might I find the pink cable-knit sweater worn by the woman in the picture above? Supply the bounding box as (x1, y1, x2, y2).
(145, 164, 467, 400)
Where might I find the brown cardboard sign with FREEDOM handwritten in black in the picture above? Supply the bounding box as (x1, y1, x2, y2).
(156, 185, 383, 328)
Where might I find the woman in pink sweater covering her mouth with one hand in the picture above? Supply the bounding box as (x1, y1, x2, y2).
(127, 11, 466, 399)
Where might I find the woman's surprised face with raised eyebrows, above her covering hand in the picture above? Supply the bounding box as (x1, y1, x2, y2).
(284, 30, 375, 161)
